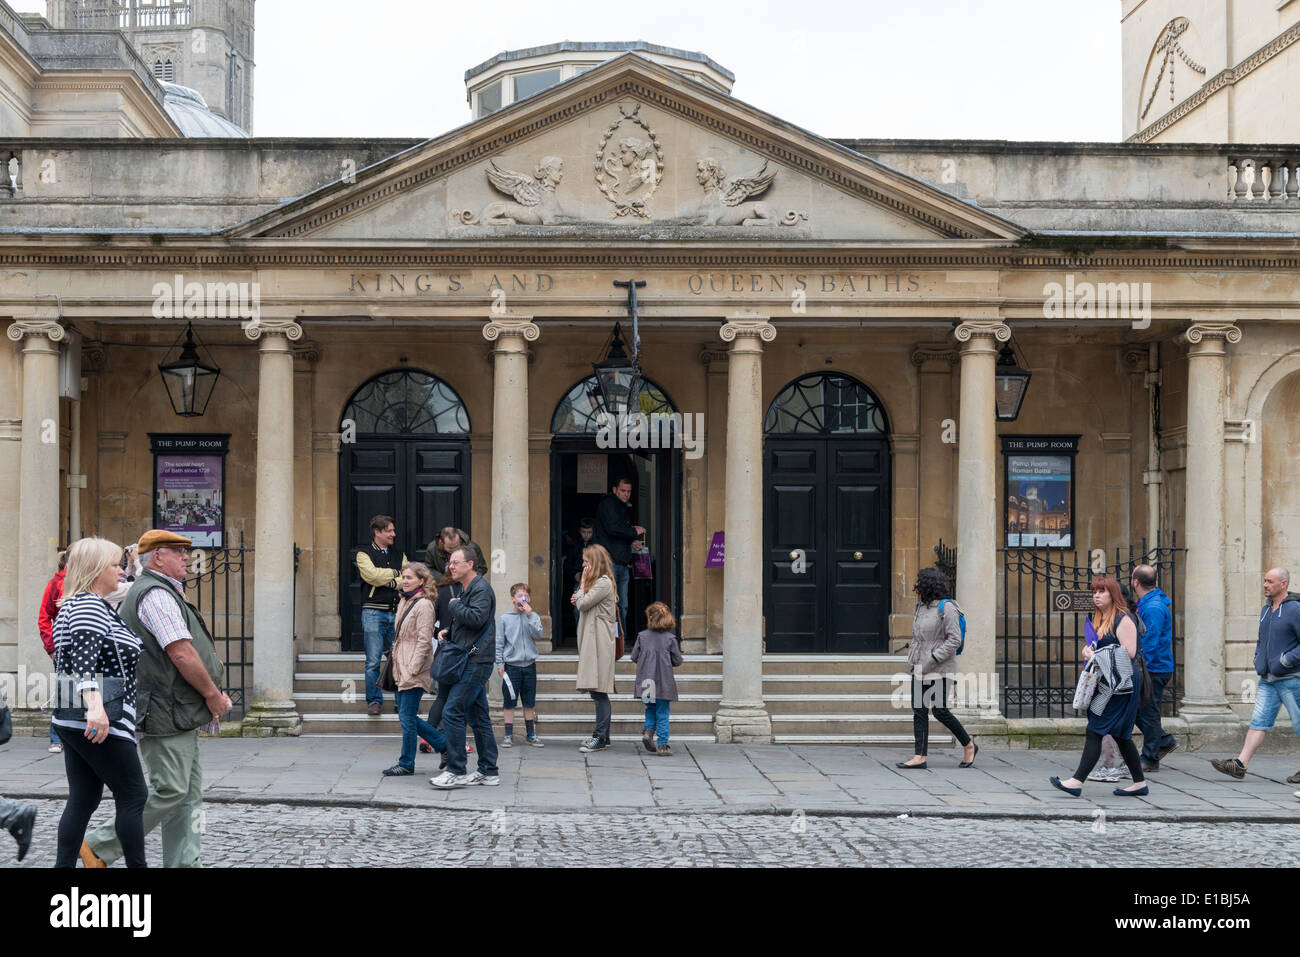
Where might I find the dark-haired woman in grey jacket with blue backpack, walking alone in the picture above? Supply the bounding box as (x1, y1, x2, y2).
(896, 568, 979, 770)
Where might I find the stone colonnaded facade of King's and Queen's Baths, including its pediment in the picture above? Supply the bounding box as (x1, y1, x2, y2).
(0, 27, 1300, 741)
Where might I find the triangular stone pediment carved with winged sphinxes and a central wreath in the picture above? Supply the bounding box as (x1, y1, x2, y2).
(228, 53, 1026, 244)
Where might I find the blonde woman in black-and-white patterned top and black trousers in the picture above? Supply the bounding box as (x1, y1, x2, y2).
(53, 538, 148, 867)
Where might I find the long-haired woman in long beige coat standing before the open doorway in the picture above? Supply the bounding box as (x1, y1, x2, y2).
(569, 545, 619, 754)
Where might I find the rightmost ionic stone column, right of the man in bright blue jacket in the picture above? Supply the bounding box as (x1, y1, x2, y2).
(1179, 322, 1242, 723)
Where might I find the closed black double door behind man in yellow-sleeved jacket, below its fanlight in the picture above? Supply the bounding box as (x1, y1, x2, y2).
(339, 437, 473, 651)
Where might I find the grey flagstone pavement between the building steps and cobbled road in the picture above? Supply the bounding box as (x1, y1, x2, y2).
(0, 735, 1300, 823)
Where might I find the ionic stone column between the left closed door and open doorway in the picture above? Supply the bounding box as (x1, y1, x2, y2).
(484, 316, 542, 612)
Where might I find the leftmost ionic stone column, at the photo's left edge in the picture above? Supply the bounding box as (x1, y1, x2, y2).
(5, 316, 65, 709)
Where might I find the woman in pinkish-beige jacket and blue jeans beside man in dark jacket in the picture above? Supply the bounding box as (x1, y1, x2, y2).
(384, 562, 447, 778)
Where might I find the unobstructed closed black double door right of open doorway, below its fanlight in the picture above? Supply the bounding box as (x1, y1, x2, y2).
(763, 436, 891, 654)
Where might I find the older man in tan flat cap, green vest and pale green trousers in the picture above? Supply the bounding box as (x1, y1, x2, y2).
(81, 528, 230, 867)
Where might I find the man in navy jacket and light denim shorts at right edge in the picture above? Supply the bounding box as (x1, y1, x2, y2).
(1210, 568, 1300, 783)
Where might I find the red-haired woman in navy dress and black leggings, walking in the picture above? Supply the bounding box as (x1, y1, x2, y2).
(1048, 576, 1148, 797)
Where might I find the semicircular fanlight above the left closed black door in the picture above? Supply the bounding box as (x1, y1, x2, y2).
(343, 369, 469, 436)
